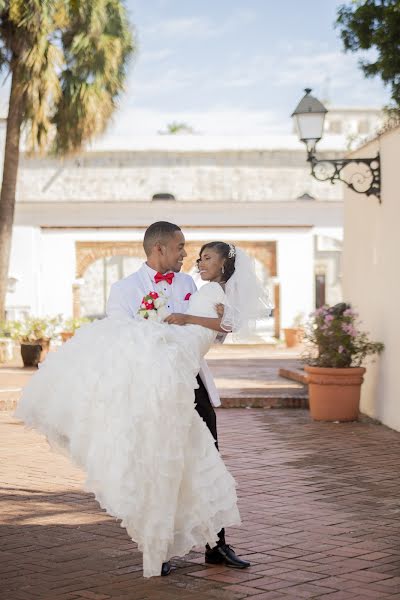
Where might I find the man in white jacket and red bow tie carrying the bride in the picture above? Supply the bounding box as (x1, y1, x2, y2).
(107, 221, 250, 576)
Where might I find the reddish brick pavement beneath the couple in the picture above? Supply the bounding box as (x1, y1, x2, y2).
(0, 409, 400, 600)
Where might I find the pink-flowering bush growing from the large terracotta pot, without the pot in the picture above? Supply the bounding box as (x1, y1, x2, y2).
(303, 302, 384, 369)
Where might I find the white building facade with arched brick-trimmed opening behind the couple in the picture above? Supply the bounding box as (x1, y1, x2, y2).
(7, 109, 382, 336)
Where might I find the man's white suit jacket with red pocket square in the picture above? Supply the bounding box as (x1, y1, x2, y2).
(107, 263, 221, 406)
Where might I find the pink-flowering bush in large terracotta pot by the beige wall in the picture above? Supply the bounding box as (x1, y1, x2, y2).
(303, 302, 384, 421)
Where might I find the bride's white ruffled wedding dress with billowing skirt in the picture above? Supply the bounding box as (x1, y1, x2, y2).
(15, 283, 240, 577)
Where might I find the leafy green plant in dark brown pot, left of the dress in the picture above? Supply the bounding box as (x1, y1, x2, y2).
(13, 316, 61, 367)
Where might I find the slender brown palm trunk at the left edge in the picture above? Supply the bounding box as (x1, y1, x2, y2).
(0, 67, 23, 320)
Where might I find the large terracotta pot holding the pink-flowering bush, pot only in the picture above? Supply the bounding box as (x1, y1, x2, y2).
(304, 366, 365, 421)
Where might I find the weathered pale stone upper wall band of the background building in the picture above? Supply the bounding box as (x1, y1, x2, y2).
(17, 150, 342, 203)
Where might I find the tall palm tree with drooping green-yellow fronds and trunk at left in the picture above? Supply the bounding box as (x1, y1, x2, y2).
(0, 0, 134, 319)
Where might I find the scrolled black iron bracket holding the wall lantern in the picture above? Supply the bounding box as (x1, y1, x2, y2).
(307, 150, 381, 202)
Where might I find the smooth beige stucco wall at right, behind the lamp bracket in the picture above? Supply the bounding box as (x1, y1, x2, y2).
(343, 127, 400, 431)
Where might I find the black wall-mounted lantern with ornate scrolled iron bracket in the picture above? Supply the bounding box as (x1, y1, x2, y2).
(292, 88, 381, 202)
